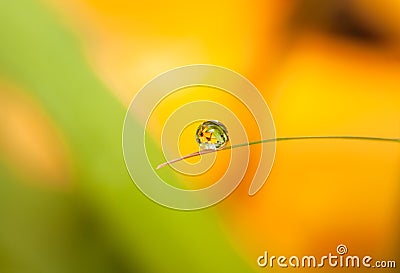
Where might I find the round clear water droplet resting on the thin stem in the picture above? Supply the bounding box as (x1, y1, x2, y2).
(196, 120, 229, 150)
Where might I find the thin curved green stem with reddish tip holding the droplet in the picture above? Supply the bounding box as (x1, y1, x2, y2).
(156, 136, 400, 170)
